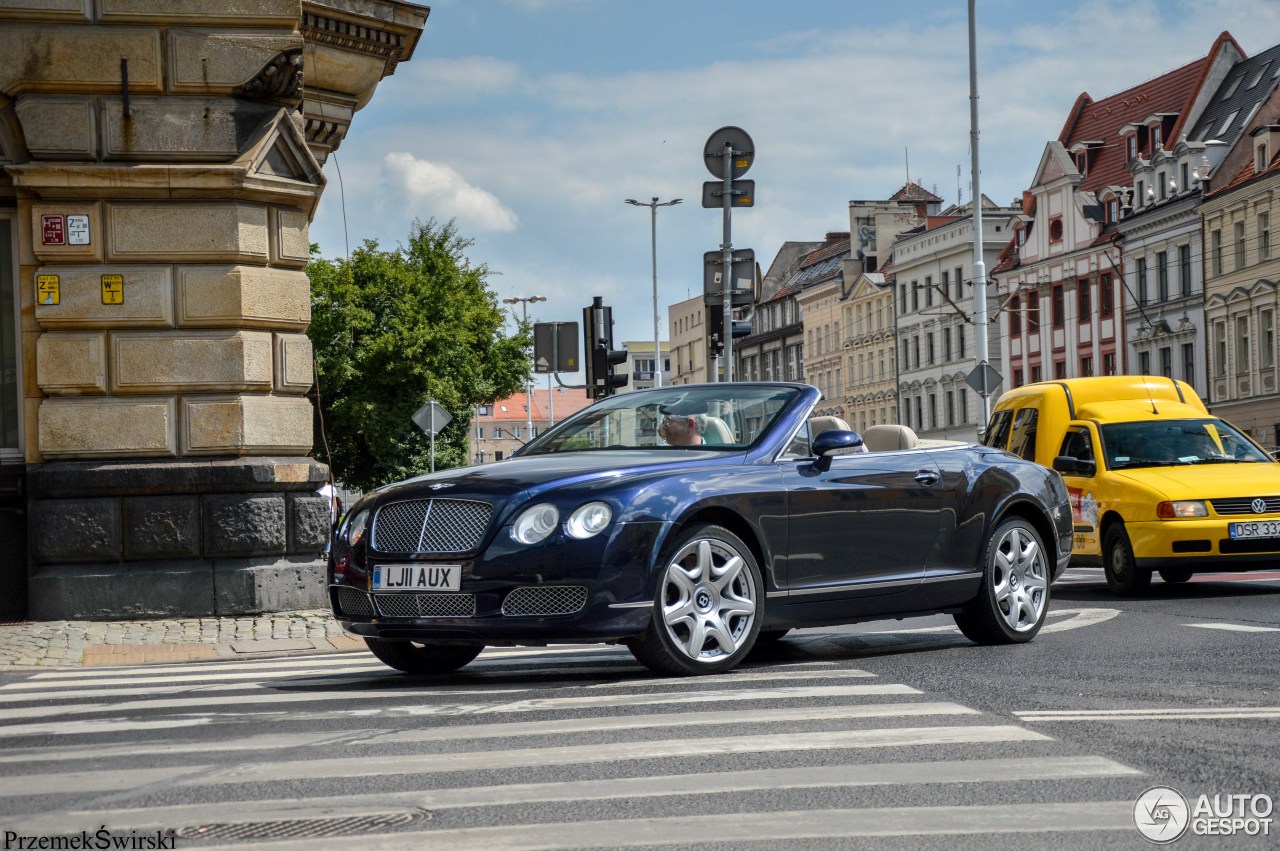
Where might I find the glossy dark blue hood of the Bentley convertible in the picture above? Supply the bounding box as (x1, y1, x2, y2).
(375, 449, 741, 498)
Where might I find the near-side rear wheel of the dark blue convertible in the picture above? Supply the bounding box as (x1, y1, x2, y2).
(955, 517, 1051, 644)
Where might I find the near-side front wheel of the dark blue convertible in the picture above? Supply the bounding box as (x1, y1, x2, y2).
(627, 523, 764, 677)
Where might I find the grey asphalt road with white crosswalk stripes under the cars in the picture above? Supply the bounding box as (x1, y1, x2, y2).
(0, 571, 1280, 851)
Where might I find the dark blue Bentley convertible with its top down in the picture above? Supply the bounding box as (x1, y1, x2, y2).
(329, 383, 1071, 674)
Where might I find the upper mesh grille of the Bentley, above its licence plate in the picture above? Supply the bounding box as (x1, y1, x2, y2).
(374, 499, 493, 553)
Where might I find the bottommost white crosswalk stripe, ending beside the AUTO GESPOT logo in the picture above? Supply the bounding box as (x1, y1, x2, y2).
(192, 800, 1134, 851)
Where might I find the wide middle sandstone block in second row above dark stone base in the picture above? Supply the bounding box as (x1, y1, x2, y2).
(111, 330, 274, 394)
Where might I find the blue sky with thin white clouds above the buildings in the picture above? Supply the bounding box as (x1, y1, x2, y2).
(311, 0, 1280, 371)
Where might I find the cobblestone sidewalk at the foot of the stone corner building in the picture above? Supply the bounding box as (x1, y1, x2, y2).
(0, 610, 365, 671)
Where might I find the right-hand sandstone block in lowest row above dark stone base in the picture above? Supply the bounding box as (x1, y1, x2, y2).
(182, 394, 314, 456)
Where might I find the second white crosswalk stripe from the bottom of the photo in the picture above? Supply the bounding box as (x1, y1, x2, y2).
(6, 756, 1143, 836)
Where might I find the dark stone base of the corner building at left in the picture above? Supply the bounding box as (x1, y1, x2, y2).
(27, 458, 329, 621)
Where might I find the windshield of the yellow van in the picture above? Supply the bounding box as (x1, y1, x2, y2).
(1101, 418, 1271, 470)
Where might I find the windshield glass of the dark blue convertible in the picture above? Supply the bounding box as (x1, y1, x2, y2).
(520, 383, 800, 456)
